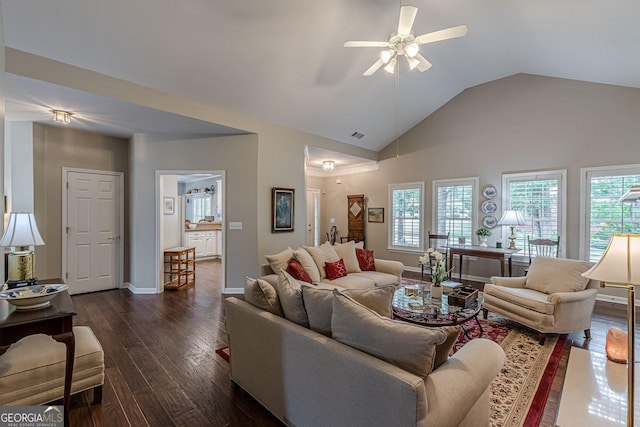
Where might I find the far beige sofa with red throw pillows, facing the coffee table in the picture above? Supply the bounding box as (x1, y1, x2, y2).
(261, 241, 404, 289)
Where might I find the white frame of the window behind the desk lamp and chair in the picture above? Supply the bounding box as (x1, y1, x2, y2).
(500, 169, 567, 262)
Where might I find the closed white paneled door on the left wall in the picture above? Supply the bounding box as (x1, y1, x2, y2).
(63, 170, 122, 294)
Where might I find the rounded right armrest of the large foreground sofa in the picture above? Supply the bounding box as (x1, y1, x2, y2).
(425, 338, 506, 426)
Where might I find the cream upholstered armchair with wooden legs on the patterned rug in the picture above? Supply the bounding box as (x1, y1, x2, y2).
(483, 257, 598, 344)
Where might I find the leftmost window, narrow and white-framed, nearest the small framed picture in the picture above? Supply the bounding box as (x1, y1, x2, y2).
(389, 182, 424, 251)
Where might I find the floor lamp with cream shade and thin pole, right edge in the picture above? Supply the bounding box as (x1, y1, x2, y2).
(582, 234, 640, 426)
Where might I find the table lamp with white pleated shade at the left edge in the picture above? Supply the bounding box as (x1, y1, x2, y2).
(0, 212, 44, 287)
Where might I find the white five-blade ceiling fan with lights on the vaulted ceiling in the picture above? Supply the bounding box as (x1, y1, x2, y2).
(344, 6, 467, 76)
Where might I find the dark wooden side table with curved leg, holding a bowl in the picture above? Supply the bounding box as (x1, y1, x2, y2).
(0, 279, 76, 427)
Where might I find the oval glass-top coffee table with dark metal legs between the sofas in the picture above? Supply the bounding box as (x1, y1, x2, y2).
(392, 286, 484, 339)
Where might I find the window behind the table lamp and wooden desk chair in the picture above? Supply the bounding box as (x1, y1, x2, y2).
(502, 170, 567, 257)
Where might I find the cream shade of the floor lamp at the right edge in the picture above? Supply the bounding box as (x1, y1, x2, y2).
(582, 234, 640, 285)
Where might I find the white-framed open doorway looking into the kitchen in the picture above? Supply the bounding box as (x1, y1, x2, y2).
(156, 170, 226, 293)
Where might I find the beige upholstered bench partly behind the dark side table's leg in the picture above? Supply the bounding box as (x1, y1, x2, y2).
(0, 326, 104, 406)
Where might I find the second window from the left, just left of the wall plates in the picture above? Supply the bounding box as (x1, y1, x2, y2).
(432, 178, 478, 244)
